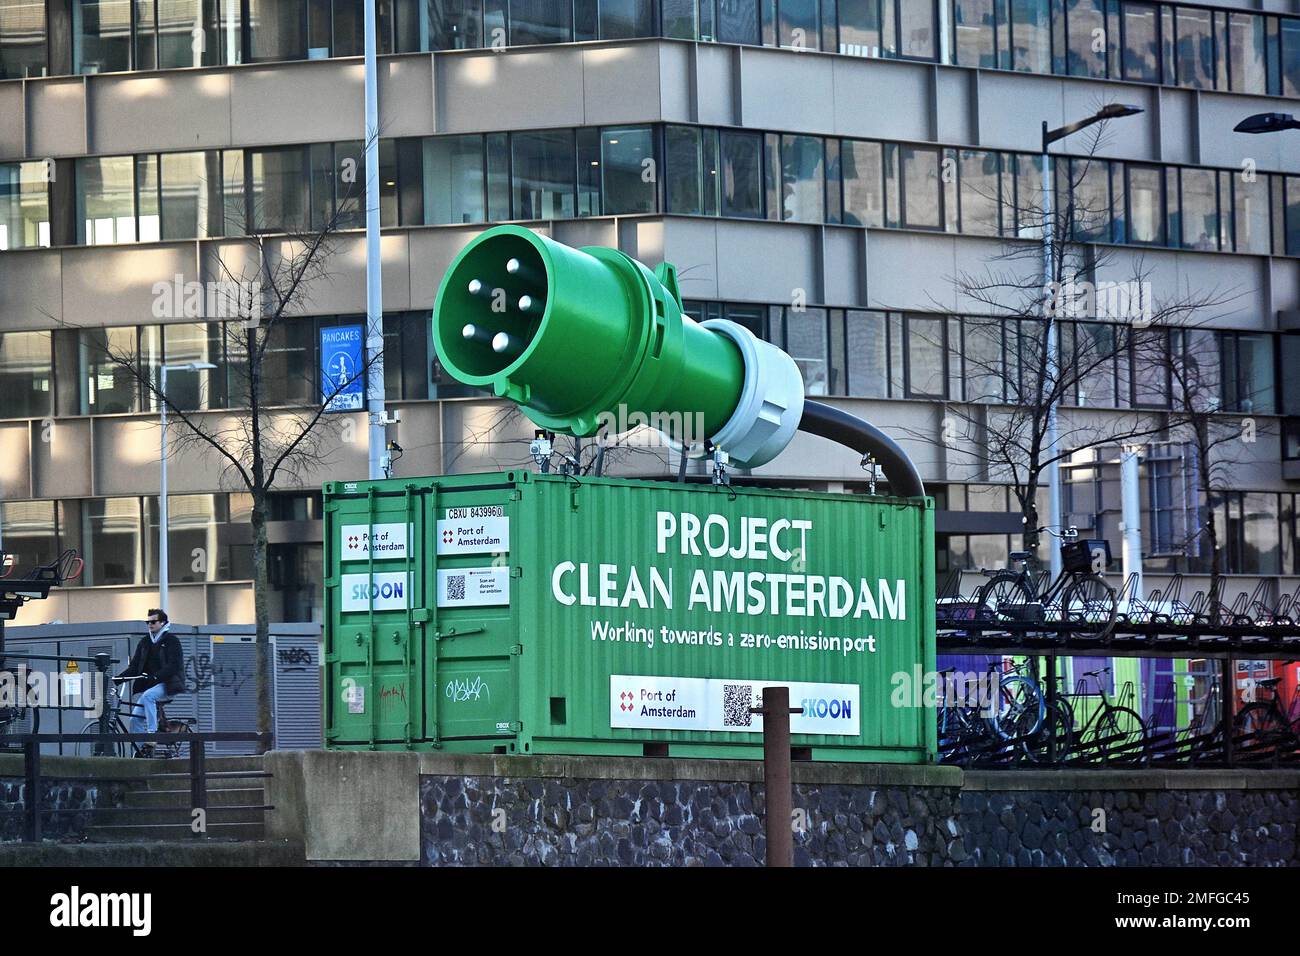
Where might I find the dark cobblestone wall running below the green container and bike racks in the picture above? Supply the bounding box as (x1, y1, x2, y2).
(420, 775, 1300, 866)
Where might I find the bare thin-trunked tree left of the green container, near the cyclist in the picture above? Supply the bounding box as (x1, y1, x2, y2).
(69, 153, 382, 749)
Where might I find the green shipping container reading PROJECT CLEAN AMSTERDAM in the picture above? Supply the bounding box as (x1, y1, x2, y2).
(324, 471, 935, 762)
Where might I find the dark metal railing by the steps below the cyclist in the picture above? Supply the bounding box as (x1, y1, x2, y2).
(0, 731, 276, 843)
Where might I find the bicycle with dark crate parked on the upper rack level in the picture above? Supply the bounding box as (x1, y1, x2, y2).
(975, 528, 1119, 639)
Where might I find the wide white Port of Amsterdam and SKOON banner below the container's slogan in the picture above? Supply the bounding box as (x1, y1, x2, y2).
(610, 674, 862, 737)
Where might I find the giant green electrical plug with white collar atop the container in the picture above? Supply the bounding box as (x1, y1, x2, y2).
(433, 225, 803, 467)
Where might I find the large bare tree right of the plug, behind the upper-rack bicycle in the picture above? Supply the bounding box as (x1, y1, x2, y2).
(909, 117, 1219, 567)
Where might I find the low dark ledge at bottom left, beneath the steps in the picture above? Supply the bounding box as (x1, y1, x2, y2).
(0, 840, 304, 868)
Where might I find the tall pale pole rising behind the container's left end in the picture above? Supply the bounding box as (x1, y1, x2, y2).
(365, 0, 387, 480)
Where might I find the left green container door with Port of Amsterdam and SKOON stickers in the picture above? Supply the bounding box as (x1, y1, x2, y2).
(324, 484, 430, 747)
